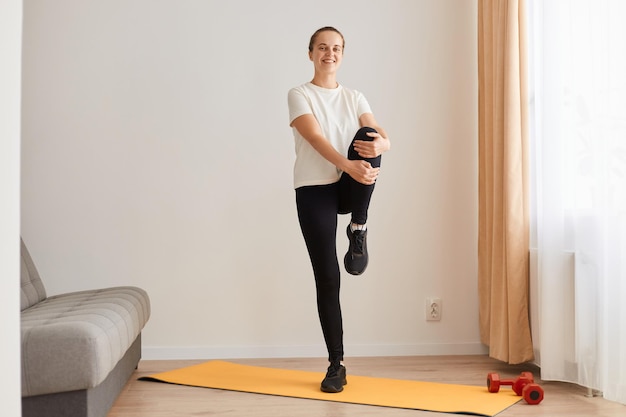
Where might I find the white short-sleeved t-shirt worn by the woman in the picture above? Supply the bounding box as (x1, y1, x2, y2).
(287, 82, 372, 188)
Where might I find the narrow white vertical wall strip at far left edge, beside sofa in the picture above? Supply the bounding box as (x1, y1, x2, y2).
(0, 0, 22, 417)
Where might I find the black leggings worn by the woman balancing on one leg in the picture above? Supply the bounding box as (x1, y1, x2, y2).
(296, 127, 381, 362)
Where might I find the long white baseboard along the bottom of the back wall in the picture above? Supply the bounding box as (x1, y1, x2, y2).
(142, 342, 489, 360)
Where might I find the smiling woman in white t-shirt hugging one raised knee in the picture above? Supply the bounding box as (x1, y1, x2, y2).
(288, 26, 390, 393)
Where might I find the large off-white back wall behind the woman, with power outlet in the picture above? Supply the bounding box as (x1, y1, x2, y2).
(22, 0, 484, 358)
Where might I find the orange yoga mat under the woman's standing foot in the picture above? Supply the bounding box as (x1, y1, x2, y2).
(140, 361, 520, 416)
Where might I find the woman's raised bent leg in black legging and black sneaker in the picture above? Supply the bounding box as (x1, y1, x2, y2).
(339, 127, 382, 275)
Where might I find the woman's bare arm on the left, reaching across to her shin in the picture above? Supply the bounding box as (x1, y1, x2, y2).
(291, 114, 380, 185)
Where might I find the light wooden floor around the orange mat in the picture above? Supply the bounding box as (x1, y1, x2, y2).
(108, 356, 626, 417)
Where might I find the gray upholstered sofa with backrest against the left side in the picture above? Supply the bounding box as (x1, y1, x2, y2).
(21, 237, 150, 417)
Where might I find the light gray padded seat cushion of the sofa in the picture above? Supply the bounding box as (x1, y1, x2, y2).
(22, 287, 150, 397)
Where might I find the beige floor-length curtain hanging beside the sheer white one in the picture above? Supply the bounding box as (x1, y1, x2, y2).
(478, 0, 533, 364)
